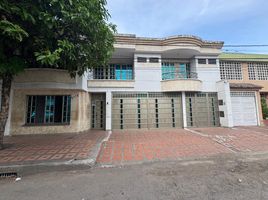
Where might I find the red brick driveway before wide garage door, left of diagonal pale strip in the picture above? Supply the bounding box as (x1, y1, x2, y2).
(97, 129, 230, 164)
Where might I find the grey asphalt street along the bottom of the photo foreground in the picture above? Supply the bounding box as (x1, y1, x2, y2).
(0, 154, 268, 200)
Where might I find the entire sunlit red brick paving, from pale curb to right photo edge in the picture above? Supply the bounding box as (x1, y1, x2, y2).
(97, 127, 268, 165)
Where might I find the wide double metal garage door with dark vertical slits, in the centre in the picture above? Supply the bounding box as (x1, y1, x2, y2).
(112, 93, 182, 129)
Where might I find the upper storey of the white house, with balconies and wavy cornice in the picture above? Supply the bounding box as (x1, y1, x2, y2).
(88, 35, 223, 92)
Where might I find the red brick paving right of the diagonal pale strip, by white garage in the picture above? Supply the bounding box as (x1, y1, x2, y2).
(193, 127, 268, 152)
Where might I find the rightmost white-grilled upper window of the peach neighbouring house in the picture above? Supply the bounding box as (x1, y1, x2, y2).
(248, 63, 268, 80)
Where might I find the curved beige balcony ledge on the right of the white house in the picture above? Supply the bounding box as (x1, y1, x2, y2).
(161, 79, 202, 92)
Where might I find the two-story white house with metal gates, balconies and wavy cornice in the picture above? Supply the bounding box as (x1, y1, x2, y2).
(88, 35, 223, 130)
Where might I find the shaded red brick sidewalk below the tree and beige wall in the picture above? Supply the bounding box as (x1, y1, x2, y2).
(0, 131, 105, 165)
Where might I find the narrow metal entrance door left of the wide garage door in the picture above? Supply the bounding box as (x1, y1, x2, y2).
(91, 93, 106, 129)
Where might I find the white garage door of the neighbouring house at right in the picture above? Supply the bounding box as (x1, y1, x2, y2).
(231, 92, 258, 126)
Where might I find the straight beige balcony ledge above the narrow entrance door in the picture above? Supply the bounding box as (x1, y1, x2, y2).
(87, 80, 135, 88)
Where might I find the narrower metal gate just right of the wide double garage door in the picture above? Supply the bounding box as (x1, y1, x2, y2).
(186, 93, 220, 127)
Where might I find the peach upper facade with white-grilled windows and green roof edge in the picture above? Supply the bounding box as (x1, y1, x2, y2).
(219, 53, 268, 92)
